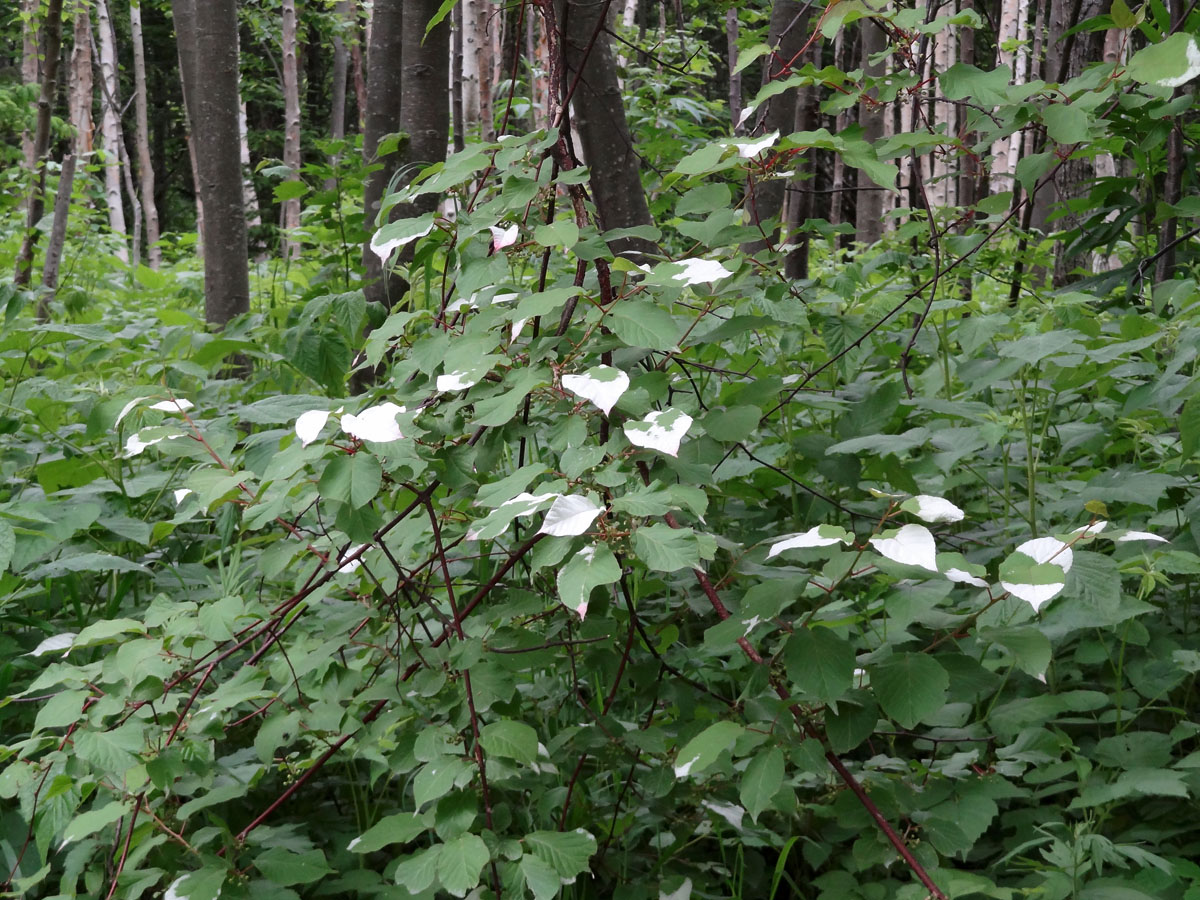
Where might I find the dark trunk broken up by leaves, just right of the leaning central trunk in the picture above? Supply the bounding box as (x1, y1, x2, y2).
(742, 0, 805, 253)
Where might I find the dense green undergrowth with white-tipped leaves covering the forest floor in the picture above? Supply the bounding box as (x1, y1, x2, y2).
(0, 19, 1200, 900)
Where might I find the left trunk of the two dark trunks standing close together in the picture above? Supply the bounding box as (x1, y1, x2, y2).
(362, 0, 404, 306)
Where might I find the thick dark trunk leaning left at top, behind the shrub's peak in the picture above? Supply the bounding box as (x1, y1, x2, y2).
(559, 0, 658, 256)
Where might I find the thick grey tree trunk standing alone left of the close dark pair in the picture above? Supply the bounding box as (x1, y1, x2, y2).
(172, 0, 250, 328)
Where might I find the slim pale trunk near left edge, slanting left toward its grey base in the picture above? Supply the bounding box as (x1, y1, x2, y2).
(37, 6, 92, 322)
